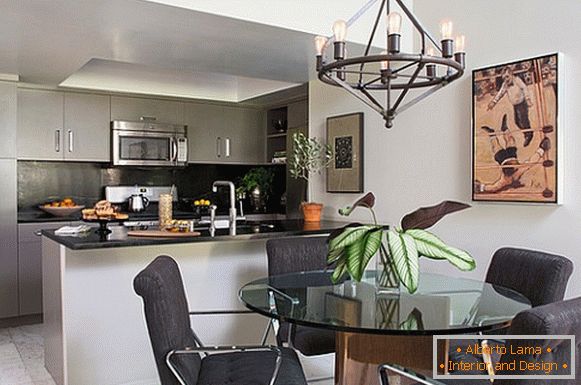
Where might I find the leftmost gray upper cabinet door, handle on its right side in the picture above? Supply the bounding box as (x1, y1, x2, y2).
(16, 89, 64, 160)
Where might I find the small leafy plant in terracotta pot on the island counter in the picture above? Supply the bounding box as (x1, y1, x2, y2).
(289, 133, 333, 222)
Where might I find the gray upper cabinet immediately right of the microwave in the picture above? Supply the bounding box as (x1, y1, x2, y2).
(184, 103, 265, 164)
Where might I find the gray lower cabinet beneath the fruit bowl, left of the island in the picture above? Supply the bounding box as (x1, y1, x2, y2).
(18, 222, 70, 316)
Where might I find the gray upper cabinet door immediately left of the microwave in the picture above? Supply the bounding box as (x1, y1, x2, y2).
(64, 92, 111, 162)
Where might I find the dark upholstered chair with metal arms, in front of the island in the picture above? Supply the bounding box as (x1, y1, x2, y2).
(133, 256, 307, 385)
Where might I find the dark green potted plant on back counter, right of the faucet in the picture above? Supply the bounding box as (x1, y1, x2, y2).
(236, 167, 274, 212)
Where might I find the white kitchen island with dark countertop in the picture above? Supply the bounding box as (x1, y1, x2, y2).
(42, 221, 344, 385)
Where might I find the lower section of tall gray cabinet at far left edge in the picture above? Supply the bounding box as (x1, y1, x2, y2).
(0, 159, 18, 318)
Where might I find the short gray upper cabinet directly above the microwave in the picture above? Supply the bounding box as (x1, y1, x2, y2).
(111, 96, 184, 124)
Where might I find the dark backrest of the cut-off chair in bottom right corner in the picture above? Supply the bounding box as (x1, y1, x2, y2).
(494, 297, 581, 385)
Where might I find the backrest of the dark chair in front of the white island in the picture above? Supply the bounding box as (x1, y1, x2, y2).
(133, 256, 201, 385)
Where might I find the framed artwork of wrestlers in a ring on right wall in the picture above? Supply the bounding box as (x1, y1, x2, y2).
(472, 53, 562, 203)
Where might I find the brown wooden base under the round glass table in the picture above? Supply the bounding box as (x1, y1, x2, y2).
(335, 332, 448, 385)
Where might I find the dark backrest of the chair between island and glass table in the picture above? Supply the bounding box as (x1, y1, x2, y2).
(266, 237, 328, 276)
